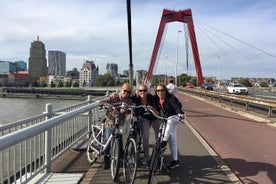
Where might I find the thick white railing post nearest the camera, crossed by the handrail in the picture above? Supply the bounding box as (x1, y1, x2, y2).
(45, 103, 53, 173)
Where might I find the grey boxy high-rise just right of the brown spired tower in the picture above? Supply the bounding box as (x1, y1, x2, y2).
(48, 51, 66, 76)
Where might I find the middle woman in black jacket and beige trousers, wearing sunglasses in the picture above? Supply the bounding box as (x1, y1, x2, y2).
(132, 84, 160, 165)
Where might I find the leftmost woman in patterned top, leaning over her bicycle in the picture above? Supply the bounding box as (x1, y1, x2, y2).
(100, 83, 133, 169)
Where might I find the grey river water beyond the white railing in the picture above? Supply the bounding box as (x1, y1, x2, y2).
(0, 98, 80, 125)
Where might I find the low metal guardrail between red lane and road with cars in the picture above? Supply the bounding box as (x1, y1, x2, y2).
(179, 88, 276, 117)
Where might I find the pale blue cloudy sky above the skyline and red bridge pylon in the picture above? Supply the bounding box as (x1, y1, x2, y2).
(0, 0, 276, 79)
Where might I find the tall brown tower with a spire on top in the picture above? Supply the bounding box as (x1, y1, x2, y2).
(29, 36, 47, 84)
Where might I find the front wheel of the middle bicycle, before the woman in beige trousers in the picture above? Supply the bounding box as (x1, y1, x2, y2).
(123, 138, 138, 184)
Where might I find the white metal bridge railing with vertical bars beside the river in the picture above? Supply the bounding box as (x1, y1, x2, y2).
(0, 96, 108, 184)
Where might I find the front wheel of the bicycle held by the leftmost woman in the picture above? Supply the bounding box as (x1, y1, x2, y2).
(110, 136, 121, 181)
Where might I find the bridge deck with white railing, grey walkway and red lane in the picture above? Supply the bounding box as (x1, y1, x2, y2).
(0, 91, 276, 184)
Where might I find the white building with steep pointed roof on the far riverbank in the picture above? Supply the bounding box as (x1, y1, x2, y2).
(80, 61, 99, 87)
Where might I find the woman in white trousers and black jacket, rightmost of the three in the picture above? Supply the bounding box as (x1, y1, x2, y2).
(156, 84, 185, 169)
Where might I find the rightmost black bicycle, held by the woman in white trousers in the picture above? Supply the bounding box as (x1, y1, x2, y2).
(148, 109, 184, 184)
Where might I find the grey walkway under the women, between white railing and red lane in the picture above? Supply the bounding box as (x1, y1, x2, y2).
(49, 118, 240, 184)
